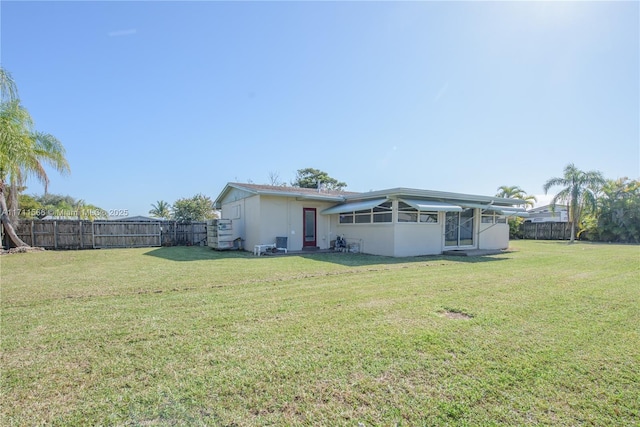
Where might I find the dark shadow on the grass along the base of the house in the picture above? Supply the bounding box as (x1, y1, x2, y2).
(145, 246, 509, 267)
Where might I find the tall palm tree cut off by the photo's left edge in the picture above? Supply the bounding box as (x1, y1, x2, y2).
(0, 68, 69, 246)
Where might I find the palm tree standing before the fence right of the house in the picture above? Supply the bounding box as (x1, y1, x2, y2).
(542, 163, 605, 243)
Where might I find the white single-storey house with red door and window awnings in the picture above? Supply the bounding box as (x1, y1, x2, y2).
(214, 183, 526, 257)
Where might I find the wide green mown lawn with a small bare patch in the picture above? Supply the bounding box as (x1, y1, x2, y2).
(0, 241, 640, 426)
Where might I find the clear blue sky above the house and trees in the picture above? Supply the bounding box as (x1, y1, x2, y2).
(0, 1, 640, 215)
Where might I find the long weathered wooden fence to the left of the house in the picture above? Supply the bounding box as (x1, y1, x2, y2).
(10, 220, 207, 249)
